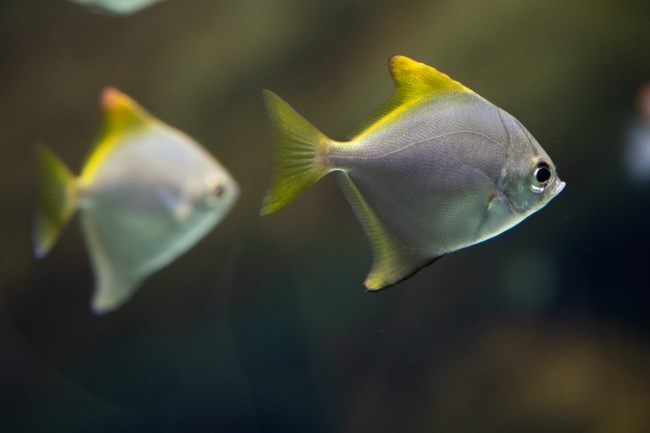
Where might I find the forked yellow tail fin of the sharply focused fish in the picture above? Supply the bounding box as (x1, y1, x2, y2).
(260, 90, 333, 215)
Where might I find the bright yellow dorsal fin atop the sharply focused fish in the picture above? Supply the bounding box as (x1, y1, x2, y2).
(350, 56, 472, 138)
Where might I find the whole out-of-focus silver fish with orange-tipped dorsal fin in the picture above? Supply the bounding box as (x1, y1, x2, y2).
(33, 87, 239, 315)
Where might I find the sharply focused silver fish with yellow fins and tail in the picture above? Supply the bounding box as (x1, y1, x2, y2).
(260, 55, 565, 291)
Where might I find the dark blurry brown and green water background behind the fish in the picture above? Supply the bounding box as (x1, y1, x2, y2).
(0, 0, 650, 433)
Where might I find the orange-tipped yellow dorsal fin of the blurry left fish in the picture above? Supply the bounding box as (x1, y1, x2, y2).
(81, 87, 156, 182)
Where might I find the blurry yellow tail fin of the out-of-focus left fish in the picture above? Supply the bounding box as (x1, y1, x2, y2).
(33, 145, 77, 258)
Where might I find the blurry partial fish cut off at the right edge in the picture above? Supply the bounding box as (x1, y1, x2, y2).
(625, 83, 650, 185)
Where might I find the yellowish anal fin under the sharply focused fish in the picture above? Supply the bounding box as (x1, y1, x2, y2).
(338, 173, 437, 291)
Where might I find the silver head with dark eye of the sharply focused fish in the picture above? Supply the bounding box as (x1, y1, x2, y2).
(502, 124, 565, 218)
